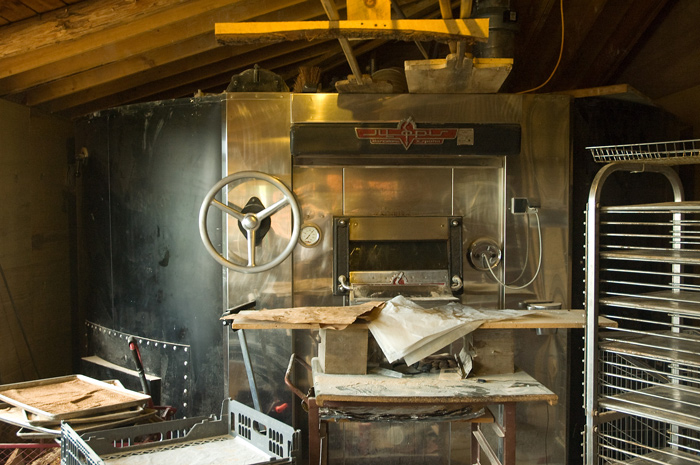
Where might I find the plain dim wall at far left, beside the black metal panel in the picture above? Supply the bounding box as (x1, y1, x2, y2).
(0, 100, 76, 384)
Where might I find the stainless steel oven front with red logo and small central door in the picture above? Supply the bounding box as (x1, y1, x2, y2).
(215, 94, 571, 463)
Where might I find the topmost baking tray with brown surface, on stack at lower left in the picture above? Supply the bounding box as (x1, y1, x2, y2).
(0, 375, 151, 420)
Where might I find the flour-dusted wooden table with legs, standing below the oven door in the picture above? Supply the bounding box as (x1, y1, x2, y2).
(285, 355, 558, 465)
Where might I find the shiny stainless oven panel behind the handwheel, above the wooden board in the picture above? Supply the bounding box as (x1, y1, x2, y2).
(225, 93, 292, 308)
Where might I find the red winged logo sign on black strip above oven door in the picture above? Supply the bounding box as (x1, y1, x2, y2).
(355, 118, 457, 150)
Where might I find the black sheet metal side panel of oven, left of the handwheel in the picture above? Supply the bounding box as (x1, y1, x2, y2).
(80, 98, 226, 416)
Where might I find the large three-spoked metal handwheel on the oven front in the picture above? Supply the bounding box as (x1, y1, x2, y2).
(199, 171, 301, 273)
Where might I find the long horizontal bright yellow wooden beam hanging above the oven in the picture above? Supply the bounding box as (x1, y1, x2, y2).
(215, 18, 489, 45)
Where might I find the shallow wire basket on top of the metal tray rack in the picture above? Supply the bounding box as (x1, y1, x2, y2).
(586, 139, 700, 165)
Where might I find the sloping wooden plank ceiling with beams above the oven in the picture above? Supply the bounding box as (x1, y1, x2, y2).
(0, 0, 674, 118)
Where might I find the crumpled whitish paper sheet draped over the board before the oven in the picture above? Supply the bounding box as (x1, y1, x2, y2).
(369, 296, 533, 365)
